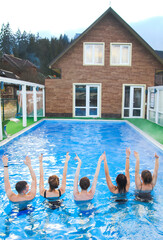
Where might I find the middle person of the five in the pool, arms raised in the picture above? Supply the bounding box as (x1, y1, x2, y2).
(73, 153, 104, 201)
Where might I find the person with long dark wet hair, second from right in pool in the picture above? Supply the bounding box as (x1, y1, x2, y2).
(104, 148, 131, 194)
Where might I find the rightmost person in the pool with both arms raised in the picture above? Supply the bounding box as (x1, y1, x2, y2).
(134, 151, 159, 191)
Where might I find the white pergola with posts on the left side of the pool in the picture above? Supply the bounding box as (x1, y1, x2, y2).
(0, 77, 45, 140)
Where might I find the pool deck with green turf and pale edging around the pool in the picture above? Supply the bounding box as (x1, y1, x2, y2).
(0, 118, 163, 150)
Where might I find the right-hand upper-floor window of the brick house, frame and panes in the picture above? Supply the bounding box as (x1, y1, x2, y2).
(110, 43, 132, 66)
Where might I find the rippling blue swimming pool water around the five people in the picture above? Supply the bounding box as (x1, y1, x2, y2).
(0, 120, 163, 240)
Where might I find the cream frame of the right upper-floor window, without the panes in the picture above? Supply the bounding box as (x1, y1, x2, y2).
(110, 42, 132, 67)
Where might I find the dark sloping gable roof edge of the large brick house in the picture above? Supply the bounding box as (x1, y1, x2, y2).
(49, 7, 163, 68)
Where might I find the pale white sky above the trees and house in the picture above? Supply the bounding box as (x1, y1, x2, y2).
(0, 0, 163, 42)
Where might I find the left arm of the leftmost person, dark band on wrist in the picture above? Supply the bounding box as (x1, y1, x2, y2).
(2, 155, 16, 201)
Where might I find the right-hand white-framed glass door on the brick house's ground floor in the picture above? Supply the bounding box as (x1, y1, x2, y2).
(123, 86, 144, 118)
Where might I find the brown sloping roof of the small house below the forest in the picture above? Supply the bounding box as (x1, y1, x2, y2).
(2, 54, 37, 70)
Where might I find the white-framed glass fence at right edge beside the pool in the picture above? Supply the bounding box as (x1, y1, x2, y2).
(147, 86, 163, 126)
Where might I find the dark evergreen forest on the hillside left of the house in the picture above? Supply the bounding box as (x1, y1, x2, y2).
(0, 23, 72, 76)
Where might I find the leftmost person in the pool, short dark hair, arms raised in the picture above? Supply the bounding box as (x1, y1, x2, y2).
(2, 155, 37, 202)
